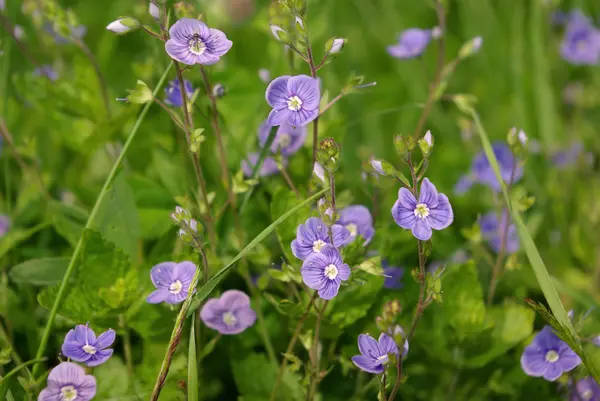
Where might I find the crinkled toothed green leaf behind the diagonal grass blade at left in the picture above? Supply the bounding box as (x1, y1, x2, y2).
(38, 230, 131, 321)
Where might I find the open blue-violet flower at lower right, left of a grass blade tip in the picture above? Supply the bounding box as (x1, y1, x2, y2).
(521, 326, 581, 382)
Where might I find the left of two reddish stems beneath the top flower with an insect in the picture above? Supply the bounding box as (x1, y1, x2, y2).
(173, 60, 217, 252)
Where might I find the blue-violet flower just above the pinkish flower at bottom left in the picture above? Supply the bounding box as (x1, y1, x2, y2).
(62, 324, 115, 366)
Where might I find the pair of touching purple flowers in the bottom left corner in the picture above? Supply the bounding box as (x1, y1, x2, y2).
(38, 324, 115, 401)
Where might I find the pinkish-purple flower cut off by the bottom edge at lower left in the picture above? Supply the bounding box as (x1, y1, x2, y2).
(38, 362, 96, 401)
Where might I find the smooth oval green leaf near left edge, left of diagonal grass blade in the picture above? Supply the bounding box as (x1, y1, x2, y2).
(9, 258, 69, 286)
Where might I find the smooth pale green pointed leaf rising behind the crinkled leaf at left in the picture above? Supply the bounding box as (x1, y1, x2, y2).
(90, 174, 140, 260)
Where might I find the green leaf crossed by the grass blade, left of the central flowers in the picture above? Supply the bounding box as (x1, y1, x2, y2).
(271, 187, 312, 263)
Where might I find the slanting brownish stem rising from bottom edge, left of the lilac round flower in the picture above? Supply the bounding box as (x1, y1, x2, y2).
(150, 248, 208, 401)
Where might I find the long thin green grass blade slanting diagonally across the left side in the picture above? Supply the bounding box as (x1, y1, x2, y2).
(33, 65, 171, 377)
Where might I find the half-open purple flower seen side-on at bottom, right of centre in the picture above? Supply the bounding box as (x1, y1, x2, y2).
(352, 333, 399, 374)
